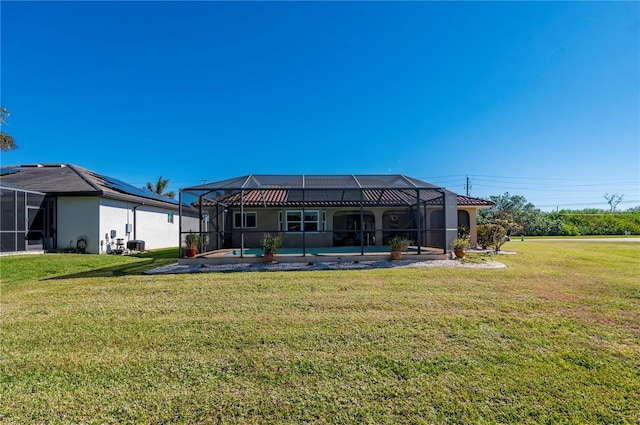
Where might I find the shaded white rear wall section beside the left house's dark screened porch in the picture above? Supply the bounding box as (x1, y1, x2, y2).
(56, 196, 100, 254)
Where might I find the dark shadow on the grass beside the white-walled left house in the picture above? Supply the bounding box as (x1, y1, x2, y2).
(47, 248, 178, 280)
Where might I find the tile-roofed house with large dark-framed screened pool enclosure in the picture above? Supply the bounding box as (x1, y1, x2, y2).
(180, 175, 493, 251)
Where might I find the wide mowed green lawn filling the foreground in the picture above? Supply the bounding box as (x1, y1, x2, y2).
(0, 241, 640, 424)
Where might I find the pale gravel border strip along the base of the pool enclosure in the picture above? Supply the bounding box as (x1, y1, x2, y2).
(145, 260, 506, 275)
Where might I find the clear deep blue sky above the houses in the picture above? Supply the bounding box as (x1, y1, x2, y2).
(0, 0, 640, 210)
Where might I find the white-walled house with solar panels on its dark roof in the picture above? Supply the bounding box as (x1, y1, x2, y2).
(0, 164, 197, 254)
